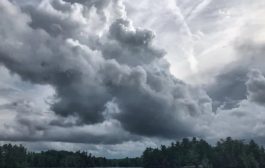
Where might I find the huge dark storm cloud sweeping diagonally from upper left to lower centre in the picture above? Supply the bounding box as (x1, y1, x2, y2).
(0, 1, 211, 143)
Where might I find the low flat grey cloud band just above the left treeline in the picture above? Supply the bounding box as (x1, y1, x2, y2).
(0, 119, 142, 144)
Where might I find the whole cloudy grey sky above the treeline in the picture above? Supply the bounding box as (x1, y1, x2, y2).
(0, 0, 265, 158)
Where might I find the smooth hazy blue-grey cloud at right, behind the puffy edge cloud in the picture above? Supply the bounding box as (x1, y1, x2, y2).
(206, 41, 265, 109)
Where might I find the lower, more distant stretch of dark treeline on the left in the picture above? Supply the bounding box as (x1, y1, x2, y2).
(0, 144, 142, 168)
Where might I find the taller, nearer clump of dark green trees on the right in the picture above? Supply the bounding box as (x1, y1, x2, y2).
(142, 138, 265, 168)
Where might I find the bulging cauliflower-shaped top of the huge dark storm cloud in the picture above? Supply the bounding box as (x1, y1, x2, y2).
(102, 19, 164, 66)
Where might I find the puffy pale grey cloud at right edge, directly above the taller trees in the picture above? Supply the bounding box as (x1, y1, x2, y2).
(205, 70, 265, 144)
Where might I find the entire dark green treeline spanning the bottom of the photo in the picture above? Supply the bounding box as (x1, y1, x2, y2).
(0, 138, 265, 168)
